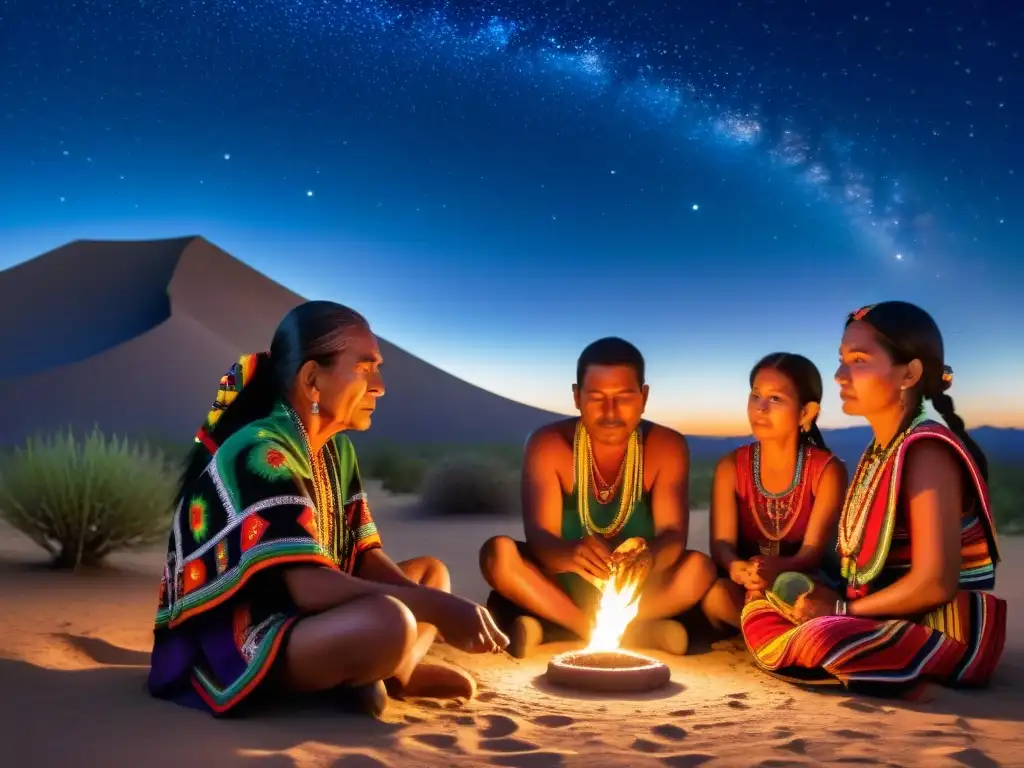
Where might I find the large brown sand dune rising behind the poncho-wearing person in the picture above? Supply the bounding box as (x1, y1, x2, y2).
(0, 238, 557, 444)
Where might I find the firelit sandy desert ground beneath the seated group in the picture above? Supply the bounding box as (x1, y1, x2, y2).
(0, 483, 1024, 768)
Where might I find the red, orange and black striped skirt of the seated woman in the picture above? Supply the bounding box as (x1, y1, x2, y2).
(740, 591, 1007, 696)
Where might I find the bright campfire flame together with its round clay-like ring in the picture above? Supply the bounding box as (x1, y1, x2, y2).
(547, 539, 672, 693)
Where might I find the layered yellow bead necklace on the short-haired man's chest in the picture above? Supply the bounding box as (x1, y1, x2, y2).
(572, 422, 643, 538)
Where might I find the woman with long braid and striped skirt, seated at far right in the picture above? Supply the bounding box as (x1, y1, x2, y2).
(741, 301, 1007, 695)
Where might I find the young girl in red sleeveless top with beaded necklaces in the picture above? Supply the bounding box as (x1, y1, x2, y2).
(703, 352, 847, 628)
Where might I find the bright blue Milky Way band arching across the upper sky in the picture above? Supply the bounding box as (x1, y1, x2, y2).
(222, 0, 926, 259)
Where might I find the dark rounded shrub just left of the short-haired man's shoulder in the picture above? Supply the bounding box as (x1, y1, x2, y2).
(420, 456, 519, 516)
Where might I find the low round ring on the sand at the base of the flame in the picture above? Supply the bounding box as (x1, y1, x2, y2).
(547, 650, 672, 693)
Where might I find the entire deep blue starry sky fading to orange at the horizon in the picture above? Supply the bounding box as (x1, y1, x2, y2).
(0, 0, 1024, 432)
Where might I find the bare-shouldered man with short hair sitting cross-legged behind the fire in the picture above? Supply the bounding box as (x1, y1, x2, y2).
(480, 338, 716, 658)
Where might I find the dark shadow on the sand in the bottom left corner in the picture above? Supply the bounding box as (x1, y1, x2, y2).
(0, 651, 404, 768)
